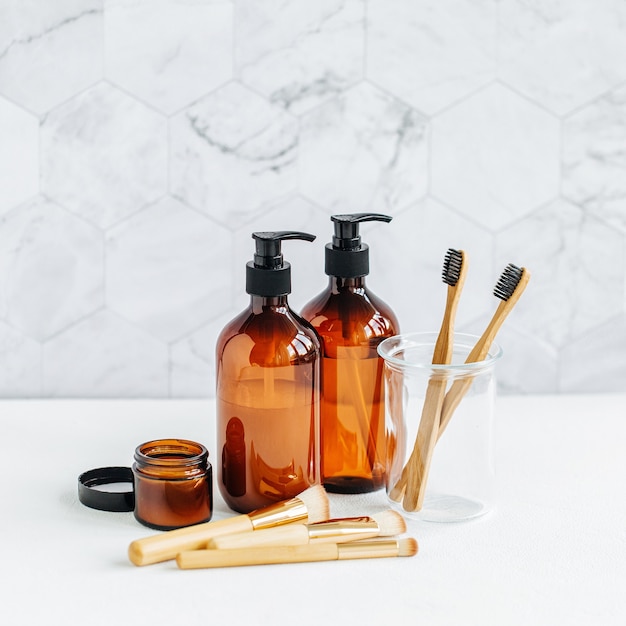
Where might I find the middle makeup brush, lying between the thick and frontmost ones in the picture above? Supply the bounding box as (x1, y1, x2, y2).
(207, 510, 406, 550)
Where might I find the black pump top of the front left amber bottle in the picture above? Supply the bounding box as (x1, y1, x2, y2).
(246, 230, 315, 297)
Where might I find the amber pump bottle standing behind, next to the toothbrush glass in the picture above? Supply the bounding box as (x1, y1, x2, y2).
(302, 213, 399, 493)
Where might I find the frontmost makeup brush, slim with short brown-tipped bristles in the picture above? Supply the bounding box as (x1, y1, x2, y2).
(176, 537, 418, 569)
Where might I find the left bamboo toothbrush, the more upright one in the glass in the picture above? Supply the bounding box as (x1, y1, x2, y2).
(389, 248, 467, 511)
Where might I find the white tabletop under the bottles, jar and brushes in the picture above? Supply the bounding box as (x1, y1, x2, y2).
(0, 394, 626, 626)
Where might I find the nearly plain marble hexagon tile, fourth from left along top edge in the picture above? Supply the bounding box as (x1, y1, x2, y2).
(367, 0, 498, 114)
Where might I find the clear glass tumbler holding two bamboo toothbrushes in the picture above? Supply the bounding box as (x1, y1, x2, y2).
(378, 333, 502, 522)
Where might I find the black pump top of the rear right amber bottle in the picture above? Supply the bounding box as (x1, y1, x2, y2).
(325, 213, 391, 278)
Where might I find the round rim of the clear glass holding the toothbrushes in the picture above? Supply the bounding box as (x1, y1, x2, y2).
(377, 331, 503, 373)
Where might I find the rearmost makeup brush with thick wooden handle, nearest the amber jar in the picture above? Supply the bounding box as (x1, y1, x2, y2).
(128, 485, 329, 565)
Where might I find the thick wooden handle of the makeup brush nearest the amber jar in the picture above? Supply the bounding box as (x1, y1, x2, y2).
(128, 515, 253, 565)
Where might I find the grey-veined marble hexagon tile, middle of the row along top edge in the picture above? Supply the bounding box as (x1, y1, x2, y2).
(235, 0, 365, 113)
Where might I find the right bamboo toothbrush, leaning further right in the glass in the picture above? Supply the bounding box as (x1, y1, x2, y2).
(438, 263, 530, 437)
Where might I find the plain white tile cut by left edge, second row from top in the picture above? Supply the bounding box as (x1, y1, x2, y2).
(0, 98, 39, 213)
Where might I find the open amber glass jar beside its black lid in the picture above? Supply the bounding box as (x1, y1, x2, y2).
(133, 439, 213, 530)
